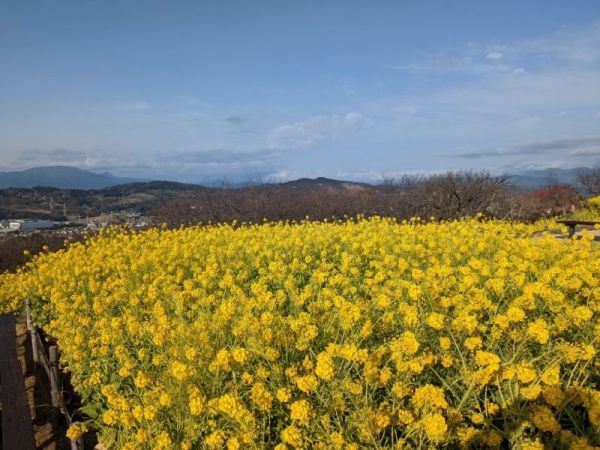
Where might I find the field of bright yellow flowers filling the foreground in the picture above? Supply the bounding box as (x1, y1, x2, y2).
(0, 218, 600, 450)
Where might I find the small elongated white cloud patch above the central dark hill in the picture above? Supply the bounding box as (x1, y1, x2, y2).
(267, 112, 374, 149)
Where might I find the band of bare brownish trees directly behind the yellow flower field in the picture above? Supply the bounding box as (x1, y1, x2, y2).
(155, 171, 572, 226)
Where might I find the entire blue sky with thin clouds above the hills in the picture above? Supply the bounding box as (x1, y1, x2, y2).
(0, 0, 600, 182)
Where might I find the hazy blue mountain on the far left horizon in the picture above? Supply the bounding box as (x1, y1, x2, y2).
(0, 166, 144, 189)
